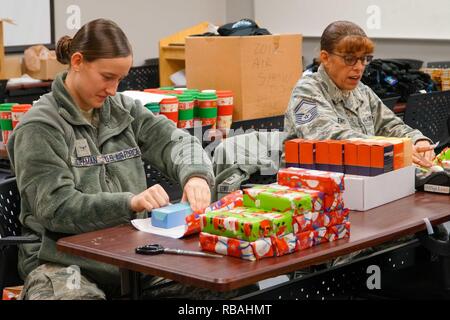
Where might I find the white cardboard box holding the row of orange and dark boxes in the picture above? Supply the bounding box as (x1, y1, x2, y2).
(344, 166, 416, 211)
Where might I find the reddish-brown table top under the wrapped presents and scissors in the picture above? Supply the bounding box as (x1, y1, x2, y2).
(57, 193, 450, 291)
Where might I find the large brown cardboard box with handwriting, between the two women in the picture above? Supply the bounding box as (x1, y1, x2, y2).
(185, 34, 303, 120)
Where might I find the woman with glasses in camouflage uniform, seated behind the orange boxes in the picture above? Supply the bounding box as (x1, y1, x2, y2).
(285, 21, 434, 167)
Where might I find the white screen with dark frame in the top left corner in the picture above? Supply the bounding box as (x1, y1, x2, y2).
(0, 0, 55, 52)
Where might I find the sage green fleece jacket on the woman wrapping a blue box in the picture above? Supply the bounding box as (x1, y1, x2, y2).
(8, 73, 214, 284)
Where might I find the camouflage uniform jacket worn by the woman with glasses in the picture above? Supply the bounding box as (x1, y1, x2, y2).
(285, 66, 429, 143)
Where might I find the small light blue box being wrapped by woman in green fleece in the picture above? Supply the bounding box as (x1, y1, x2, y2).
(152, 203, 192, 229)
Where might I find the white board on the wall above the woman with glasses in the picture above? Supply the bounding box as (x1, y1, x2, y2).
(254, 0, 450, 40)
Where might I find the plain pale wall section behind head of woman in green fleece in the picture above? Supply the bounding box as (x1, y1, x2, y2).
(55, 0, 227, 66)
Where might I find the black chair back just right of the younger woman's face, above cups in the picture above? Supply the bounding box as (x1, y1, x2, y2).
(118, 59, 159, 91)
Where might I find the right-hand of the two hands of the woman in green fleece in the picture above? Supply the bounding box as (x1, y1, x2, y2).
(181, 177, 211, 211)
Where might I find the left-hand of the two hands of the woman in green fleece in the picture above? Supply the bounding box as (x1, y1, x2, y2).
(131, 184, 169, 212)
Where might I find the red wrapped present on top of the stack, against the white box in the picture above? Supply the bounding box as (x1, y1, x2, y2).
(278, 168, 344, 194)
